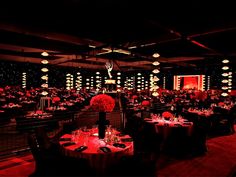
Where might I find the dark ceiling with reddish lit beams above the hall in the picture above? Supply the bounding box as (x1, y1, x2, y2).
(0, 0, 236, 71)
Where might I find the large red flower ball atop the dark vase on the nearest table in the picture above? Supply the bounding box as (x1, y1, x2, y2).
(90, 94, 115, 112)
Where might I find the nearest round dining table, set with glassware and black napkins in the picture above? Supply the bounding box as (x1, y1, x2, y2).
(59, 128, 133, 174)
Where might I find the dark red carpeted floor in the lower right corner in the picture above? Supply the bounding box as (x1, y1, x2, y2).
(157, 134, 236, 177)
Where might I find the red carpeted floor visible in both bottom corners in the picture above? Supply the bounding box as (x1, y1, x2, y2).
(0, 130, 236, 177)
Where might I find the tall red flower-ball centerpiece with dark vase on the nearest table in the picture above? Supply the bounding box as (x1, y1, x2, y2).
(90, 94, 115, 139)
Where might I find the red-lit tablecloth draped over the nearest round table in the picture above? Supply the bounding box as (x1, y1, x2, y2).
(60, 129, 133, 174)
